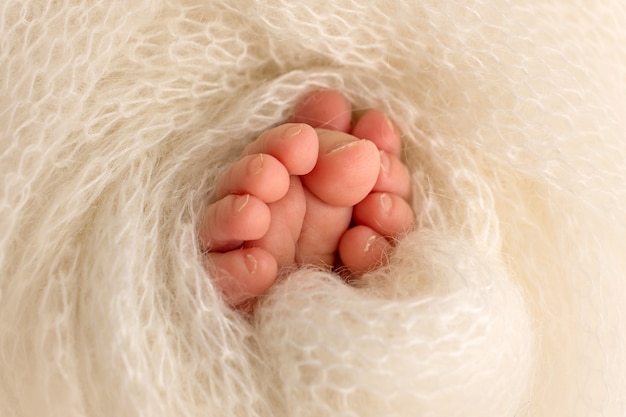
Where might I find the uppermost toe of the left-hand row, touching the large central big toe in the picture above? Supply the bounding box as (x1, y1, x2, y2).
(243, 123, 319, 175)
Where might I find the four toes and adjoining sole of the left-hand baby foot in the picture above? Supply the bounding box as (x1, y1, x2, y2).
(199, 123, 319, 305)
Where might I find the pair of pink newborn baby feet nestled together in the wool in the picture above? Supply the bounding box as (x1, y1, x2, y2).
(200, 90, 414, 306)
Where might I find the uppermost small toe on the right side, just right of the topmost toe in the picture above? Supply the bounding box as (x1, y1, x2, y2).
(350, 110, 402, 156)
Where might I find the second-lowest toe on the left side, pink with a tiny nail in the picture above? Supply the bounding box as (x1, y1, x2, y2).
(199, 194, 271, 251)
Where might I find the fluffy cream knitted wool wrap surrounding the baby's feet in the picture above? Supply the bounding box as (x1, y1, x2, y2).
(0, 0, 626, 417)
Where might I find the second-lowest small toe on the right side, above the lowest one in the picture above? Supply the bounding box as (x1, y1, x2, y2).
(353, 193, 415, 237)
